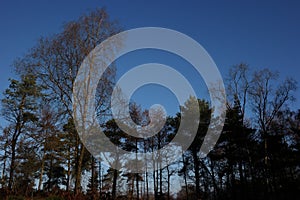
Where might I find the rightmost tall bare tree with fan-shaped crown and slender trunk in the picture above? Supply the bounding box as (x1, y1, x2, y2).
(249, 69, 296, 197)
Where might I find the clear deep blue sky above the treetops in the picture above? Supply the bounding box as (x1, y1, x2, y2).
(0, 0, 300, 117)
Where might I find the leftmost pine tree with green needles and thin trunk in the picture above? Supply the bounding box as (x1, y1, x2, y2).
(1, 74, 41, 190)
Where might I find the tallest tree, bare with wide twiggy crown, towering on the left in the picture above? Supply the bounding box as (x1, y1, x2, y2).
(16, 9, 120, 193)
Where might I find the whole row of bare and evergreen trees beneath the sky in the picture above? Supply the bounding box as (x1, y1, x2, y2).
(0, 9, 300, 200)
